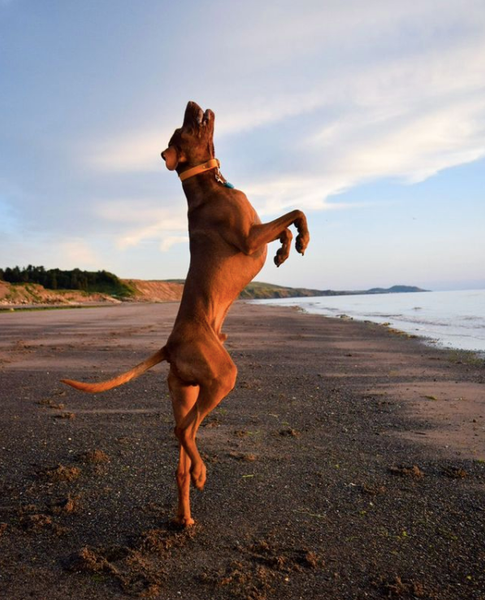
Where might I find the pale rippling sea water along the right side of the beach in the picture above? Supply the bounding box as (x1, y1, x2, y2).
(254, 290, 485, 353)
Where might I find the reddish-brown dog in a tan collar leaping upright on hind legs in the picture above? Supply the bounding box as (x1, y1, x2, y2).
(63, 102, 310, 526)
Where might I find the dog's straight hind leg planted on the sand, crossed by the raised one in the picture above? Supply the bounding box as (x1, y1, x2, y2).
(168, 370, 199, 527)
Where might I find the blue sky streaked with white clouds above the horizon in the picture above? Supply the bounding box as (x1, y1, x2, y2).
(0, 0, 485, 290)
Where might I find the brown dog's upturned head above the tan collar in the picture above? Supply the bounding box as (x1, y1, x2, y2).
(162, 102, 215, 174)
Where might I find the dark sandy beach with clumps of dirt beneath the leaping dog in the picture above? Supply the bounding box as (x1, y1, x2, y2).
(0, 302, 485, 600)
